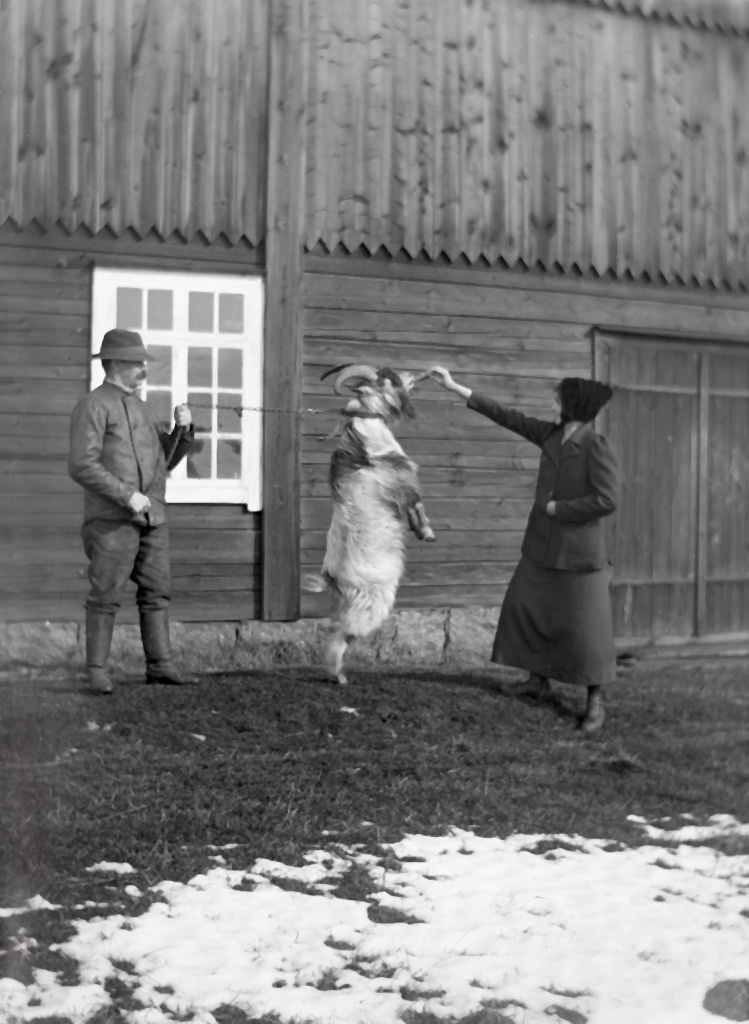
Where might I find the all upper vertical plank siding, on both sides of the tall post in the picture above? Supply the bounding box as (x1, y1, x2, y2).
(0, 0, 749, 286)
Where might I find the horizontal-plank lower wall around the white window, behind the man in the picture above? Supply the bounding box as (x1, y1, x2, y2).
(0, 225, 260, 622)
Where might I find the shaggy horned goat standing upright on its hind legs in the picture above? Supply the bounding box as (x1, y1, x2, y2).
(309, 366, 434, 684)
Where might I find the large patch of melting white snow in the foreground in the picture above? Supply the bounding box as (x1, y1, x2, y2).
(0, 815, 749, 1024)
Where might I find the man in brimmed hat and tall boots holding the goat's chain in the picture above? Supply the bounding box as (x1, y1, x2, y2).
(69, 329, 194, 693)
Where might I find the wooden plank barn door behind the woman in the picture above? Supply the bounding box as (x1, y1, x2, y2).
(595, 336, 749, 641)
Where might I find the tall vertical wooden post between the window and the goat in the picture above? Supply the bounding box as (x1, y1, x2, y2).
(262, 0, 307, 621)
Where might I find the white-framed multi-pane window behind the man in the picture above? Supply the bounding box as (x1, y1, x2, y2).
(91, 267, 263, 511)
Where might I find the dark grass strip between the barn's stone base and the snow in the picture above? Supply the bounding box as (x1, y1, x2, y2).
(0, 659, 749, 999)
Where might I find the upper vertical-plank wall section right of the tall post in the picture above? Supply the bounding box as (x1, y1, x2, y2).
(305, 0, 749, 285)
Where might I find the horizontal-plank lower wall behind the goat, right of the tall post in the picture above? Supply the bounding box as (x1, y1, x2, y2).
(301, 258, 749, 615)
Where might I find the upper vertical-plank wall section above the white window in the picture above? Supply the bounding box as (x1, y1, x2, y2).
(0, 0, 269, 245)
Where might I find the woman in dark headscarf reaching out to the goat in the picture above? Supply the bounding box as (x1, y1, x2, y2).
(431, 367, 619, 732)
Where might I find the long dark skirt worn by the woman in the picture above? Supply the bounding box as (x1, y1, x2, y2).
(492, 556, 616, 686)
